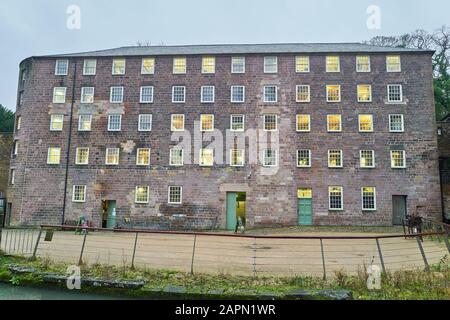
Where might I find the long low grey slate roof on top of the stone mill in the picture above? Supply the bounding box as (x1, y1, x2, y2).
(38, 43, 432, 57)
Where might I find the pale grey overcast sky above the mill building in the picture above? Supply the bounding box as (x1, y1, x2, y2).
(0, 0, 450, 110)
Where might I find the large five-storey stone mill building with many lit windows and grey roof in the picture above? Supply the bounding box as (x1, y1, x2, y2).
(7, 43, 442, 229)
